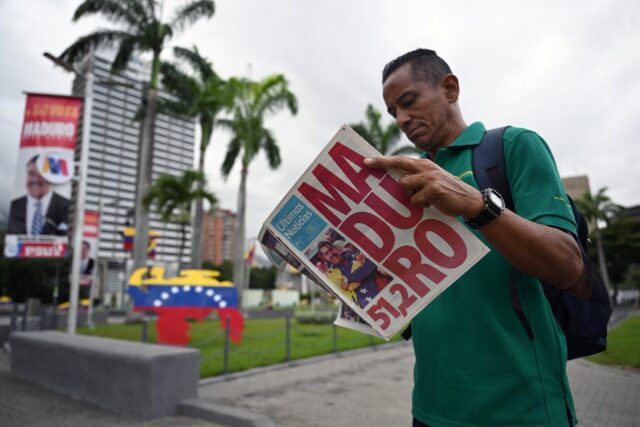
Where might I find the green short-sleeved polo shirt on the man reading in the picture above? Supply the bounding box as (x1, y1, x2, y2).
(412, 123, 576, 427)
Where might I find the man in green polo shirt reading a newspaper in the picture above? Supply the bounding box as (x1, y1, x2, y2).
(365, 49, 583, 427)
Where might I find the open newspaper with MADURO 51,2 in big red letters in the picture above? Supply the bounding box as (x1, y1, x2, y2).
(259, 125, 489, 340)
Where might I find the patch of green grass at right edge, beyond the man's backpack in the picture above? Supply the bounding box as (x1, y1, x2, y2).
(587, 316, 640, 369)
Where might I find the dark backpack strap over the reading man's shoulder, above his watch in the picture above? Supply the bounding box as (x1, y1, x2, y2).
(472, 126, 515, 211)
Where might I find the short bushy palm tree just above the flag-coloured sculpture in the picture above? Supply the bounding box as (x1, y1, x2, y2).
(143, 170, 216, 264)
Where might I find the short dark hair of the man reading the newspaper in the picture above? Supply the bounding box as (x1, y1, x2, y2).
(382, 49, 451, 85)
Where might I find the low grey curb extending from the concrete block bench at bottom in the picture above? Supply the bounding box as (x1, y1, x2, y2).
(178, 399, 276, 427)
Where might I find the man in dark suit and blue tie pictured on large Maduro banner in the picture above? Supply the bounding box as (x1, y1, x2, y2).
(7, 155, 69, 235)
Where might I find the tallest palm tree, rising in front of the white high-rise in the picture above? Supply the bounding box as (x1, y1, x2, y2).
(60, 0, 214, 268)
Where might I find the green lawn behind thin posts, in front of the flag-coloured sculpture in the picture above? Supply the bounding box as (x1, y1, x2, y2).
(78, 318, 402, 378)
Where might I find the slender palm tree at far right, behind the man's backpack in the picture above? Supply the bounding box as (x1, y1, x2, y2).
(575, 187, 621, 303)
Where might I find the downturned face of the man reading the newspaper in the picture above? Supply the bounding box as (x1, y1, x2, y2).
(382, 64, 457, 152)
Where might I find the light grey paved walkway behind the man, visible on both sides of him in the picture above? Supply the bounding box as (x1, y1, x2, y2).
(195, 345, 640, 427)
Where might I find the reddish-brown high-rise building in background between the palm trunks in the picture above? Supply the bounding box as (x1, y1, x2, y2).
(202, 209, 237, 265)
